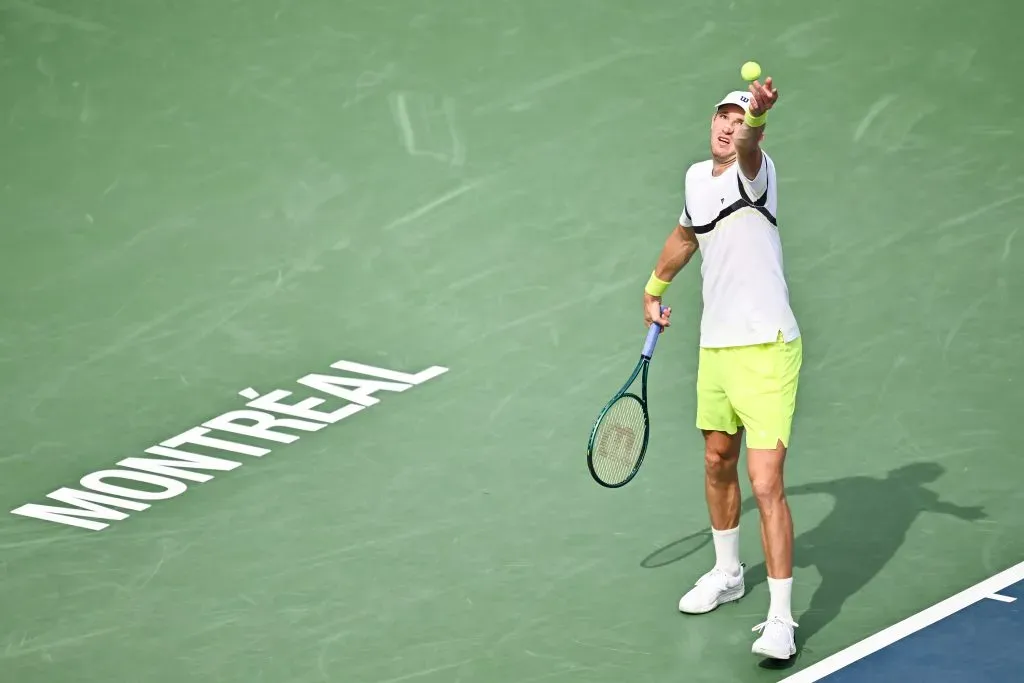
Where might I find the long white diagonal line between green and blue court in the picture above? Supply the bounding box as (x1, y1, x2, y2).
(779, 562, 1024, 683)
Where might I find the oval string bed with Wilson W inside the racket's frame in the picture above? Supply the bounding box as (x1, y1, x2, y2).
(593, 395, 647, 483)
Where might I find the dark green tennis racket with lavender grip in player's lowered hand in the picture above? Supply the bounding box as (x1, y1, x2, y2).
(587, 306, 666, 488)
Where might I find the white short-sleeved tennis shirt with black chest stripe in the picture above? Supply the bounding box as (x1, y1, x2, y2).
(679, 153, 800, 348)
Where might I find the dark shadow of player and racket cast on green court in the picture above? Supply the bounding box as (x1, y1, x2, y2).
(640, 462, 986, 667)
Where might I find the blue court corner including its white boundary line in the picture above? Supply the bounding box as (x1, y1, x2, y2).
(782, 562, 1024, 683)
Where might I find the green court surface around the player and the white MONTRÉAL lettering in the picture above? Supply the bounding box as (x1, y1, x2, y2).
(0, 0, 1024, 683)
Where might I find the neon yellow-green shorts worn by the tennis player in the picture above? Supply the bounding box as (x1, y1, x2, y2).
(697, 333, 803, 450)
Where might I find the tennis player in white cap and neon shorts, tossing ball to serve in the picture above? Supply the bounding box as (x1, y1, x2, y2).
(644, 78, 802, 659)
